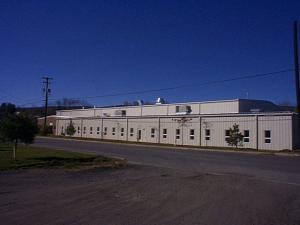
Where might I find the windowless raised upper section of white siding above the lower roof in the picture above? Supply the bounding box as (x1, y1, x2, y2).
(56, 99, 288, 117)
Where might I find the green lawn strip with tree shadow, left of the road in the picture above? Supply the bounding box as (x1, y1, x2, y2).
(0, 143, 126, 170)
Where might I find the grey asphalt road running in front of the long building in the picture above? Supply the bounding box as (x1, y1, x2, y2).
(34, 137, 300, 186)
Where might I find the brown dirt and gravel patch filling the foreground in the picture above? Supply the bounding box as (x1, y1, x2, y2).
(0, 165, 300, 225)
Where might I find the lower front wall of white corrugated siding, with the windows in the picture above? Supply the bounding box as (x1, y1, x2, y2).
(56, 114, 295, 150)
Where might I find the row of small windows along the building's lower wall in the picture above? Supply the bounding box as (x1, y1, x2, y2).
(62, 127, 271, 143)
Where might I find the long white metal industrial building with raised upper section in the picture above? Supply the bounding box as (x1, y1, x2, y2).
(56, 98, 299, 150)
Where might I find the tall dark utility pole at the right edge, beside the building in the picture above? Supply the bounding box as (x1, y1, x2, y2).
(294, 21, 300, 135)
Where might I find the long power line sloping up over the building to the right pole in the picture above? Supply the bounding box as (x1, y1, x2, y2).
(51, 69, 295, 100)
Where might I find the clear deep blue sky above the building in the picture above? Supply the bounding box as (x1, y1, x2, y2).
(0, 0, 300, 107)
